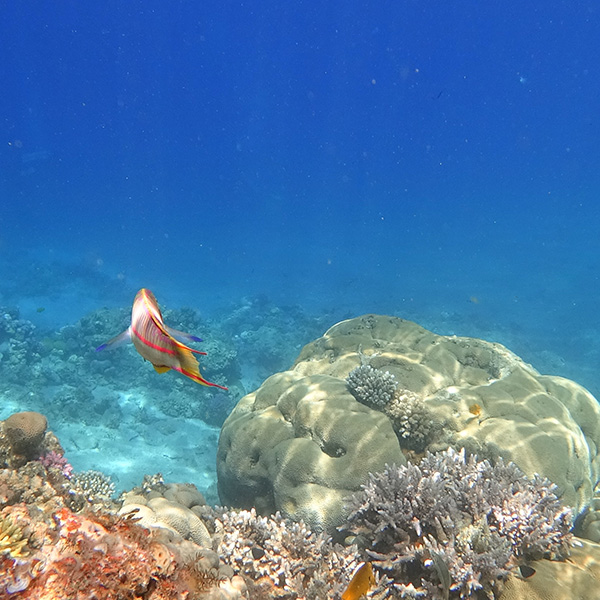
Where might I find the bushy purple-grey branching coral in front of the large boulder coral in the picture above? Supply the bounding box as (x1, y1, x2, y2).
(348, 448, 572, 599)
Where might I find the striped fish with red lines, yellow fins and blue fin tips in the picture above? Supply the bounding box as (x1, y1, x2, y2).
(96, 288, 227, 390)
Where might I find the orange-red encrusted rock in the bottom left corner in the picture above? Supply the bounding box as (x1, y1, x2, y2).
(0, 505, 202, 600)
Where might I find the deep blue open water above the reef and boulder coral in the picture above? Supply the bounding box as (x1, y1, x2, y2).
(0, 0, 600, 492)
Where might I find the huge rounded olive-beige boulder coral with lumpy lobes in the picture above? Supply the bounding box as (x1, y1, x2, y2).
(217, 315, 600, 531)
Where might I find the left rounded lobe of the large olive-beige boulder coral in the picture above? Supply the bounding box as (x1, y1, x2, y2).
(217, 371, 405, 530)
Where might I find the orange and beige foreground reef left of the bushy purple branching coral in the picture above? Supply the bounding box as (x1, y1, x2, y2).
(0, 412, 366, 600)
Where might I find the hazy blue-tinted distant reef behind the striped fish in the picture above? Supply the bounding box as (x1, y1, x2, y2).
(0, 298, 324, 428)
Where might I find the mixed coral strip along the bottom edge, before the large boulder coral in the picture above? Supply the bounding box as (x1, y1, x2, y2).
(0, 406, 600, 600)
